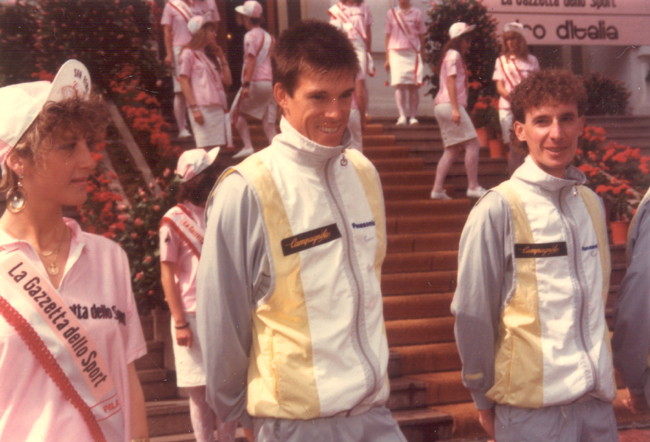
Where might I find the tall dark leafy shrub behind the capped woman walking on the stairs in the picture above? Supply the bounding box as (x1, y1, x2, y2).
(425, 0, 499, 109)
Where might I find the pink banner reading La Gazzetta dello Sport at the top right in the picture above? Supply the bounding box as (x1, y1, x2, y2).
(483, 0, 650, 46)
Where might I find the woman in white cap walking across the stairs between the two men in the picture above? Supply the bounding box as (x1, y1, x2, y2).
(431, 22, 485, 200)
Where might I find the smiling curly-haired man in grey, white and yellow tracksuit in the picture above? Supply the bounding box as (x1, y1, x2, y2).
(452, 70, 618, 442)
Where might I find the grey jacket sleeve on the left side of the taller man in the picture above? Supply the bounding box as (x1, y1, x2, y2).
(196, 173, 270, 422)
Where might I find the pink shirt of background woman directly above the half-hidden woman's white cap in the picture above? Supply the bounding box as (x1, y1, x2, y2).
(178, 49, 227, 106)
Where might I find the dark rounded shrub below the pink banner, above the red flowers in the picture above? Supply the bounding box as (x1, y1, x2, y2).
(584, 73, 630, 115)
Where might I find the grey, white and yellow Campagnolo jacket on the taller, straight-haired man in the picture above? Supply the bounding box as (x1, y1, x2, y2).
(197, 119, 389, 421)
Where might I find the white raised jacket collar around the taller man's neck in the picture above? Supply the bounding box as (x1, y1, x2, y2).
(273, 117, 352, 165)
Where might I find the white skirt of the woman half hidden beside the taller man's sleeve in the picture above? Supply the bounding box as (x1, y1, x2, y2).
(172, 313, 205, 387)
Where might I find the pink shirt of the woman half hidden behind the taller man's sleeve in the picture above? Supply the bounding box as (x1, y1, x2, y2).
(158, 202, 205, 313)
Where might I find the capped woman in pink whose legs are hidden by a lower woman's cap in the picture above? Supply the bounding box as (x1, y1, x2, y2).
(179, 14, 232, 148)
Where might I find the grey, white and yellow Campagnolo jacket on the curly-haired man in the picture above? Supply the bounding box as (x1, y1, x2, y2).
(452, 157, 616, 409)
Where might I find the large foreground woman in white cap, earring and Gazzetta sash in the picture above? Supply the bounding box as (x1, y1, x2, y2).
(0, 60, 148, 441)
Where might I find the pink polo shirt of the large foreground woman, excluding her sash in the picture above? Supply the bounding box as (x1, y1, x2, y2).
(0, 219, 147, 442)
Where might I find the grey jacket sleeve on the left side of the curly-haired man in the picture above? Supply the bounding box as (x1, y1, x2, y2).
(451, 192, 514, 410)
